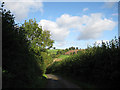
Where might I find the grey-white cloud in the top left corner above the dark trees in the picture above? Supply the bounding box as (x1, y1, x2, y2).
(3, 0, 43, 21)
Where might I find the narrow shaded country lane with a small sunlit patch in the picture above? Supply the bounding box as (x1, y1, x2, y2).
(46, 74, 81, 90)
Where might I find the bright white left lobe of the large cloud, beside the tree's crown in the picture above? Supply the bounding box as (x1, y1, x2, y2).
(39, 20, 69, 41)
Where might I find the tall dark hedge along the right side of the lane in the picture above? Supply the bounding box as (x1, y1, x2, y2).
(47, 38, 120, 87)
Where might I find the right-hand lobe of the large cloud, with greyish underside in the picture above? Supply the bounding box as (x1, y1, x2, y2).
(78, 13, 116, 40)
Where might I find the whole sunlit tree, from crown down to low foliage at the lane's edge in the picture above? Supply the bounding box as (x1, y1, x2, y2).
(22, 19, 54, 74)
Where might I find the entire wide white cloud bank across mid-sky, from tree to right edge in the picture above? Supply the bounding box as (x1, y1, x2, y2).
(39, 13, 116, 41)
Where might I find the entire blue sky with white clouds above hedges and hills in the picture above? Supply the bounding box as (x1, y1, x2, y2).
(1, 0, 118, 49)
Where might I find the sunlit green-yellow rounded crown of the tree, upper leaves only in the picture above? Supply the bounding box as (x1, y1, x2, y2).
(22, 19, 54, 49)
